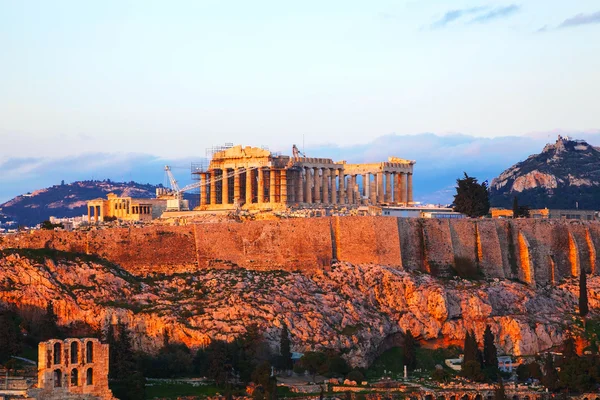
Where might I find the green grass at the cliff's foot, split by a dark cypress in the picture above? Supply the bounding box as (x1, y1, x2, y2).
(366, 347, 460, 379)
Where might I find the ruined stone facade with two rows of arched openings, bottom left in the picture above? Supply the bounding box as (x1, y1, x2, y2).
(31, 338, 114, 400)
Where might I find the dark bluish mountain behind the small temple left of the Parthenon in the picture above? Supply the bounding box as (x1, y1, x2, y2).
(0, 180, 159, 226)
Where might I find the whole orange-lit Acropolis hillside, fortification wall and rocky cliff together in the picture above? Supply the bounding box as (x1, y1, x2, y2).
(0, 217, 600, 365)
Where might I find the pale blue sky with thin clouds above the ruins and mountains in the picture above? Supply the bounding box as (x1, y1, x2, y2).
(0, 0, 600, 201)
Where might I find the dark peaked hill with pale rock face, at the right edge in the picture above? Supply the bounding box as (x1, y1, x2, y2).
(490, 136, 600, 210)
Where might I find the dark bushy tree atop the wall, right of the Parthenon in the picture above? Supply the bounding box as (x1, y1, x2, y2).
(454, 172, 490, 218)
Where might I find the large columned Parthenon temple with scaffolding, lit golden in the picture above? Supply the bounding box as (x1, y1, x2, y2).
(194, 146, 415, 209)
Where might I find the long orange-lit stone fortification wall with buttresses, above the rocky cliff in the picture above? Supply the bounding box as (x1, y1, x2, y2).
(0, 217, 600, 285)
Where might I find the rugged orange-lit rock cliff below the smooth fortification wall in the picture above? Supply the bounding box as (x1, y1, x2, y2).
(0, 249, 600, 365)
